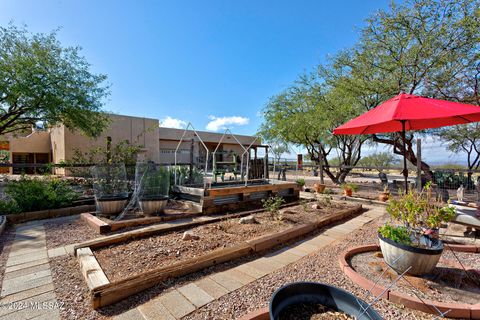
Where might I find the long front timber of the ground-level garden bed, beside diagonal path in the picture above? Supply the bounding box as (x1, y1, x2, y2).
(82, 205, 362, 309)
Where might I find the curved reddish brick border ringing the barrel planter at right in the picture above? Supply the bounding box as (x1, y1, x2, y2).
(338, 244, 480, 319)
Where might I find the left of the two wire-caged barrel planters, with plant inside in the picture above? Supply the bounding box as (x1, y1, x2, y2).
(91, 163, 128, 217)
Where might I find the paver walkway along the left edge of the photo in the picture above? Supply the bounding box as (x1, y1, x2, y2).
(0, 216, 78, 320)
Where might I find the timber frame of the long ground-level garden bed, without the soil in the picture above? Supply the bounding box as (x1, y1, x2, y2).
(75, 205, 362, 309)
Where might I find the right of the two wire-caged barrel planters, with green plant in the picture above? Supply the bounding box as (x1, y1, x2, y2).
(137, 164, 170, 216)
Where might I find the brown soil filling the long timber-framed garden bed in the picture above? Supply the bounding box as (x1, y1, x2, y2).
(93, 202, 353, 282)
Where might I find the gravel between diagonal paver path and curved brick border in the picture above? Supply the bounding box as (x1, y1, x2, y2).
(185, 218, 442, 320)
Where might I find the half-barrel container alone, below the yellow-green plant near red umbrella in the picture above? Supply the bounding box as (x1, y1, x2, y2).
(378, 234, 443, 276)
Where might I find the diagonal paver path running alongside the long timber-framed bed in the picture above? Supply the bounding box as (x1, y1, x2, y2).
(114, 205, 385, 320)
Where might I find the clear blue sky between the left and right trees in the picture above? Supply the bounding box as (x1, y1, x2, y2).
(0, 0, 464, 164)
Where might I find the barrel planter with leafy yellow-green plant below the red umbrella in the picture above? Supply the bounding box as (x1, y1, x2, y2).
(378, 183, 456, 275)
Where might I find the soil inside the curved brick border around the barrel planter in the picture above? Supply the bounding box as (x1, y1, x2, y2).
(350, 251, 480, 304)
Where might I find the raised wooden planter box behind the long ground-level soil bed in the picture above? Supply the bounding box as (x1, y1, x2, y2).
(174, 179, 300, 214)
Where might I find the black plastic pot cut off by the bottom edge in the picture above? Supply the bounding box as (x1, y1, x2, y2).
(270, 282, 383, 320)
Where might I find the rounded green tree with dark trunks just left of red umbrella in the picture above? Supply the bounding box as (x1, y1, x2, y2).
(260, 73, 366, 183)
